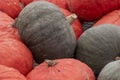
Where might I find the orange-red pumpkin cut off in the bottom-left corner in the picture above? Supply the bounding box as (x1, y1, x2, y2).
(0, 65, 27, 80)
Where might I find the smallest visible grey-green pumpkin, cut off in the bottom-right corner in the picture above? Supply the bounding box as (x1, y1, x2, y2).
(97, 60, 120, 80)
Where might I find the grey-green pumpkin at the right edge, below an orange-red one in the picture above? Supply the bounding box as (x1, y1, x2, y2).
(75, 24, 120, 76)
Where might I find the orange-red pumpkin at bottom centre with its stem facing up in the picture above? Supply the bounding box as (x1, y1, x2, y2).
(27, 58, 95, 80)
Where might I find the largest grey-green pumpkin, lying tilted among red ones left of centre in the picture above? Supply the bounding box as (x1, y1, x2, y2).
(15, 1, 76, 63)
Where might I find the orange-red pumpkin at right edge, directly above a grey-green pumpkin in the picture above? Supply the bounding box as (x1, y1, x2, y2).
(93, 10, 120, 26)
